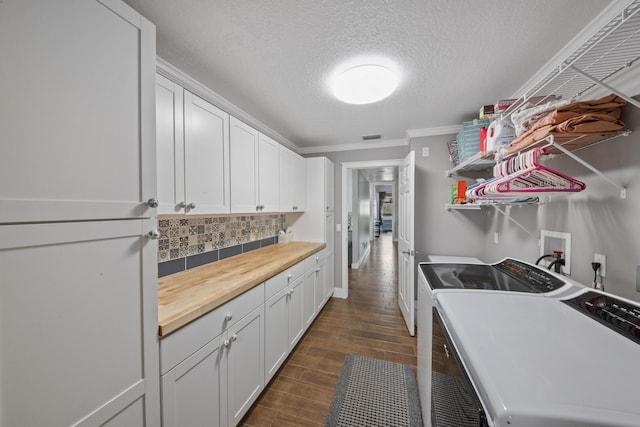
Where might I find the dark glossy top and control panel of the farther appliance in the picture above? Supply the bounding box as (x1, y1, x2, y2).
(420, 258, 566, 293)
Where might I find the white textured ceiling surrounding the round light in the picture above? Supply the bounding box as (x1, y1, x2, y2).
(125, 0, 609, 152)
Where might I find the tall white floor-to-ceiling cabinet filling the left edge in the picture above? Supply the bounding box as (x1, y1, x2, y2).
(0, 0, 160, 427)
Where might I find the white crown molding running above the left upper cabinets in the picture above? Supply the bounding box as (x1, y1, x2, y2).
(156, 57, 300, 153)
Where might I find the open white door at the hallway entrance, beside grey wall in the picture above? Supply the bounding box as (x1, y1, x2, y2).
(398, 151, 416, 336)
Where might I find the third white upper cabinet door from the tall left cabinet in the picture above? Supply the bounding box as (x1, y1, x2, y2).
(230, 117, 260, 213)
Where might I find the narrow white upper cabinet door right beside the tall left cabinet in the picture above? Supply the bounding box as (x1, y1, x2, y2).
(156, 74, 185, 214)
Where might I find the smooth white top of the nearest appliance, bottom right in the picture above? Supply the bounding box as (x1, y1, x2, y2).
(435, 291, 640, 426)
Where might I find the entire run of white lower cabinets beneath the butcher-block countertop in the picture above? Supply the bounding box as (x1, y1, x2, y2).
(160, 251, 327, 427)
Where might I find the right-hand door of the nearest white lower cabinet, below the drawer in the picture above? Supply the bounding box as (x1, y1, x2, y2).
(223, 305, 264, 426)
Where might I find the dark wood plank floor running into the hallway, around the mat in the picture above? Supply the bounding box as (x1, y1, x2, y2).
(241, 233, 416, 427)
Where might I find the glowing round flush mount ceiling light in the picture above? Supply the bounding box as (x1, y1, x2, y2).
(332, 64, 398, 104)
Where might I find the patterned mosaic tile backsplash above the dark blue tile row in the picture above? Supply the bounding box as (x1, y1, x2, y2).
(158, 214, 285, 262)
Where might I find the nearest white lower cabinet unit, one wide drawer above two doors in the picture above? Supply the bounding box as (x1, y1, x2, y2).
(160, 285, 264, 427)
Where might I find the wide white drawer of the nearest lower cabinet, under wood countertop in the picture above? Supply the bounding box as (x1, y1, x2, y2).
(160, 283, 264, 374)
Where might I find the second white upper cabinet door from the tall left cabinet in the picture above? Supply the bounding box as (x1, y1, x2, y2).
(184, 91, 231, 214)
